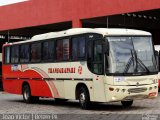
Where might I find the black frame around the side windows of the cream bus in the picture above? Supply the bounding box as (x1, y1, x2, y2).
(4, 33, 102, 64)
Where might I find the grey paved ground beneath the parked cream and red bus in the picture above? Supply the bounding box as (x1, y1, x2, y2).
(0, 92, 160, 120)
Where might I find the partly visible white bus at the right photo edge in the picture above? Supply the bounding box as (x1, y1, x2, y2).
(154, 45, 160, 91)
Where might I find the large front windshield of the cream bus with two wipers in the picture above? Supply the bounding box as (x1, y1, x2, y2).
(106, 36, 157, 75)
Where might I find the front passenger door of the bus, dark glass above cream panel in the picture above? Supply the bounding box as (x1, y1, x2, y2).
(87, 39, 105, 101)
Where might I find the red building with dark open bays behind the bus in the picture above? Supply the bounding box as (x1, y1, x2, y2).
(0, 0, 160, 46)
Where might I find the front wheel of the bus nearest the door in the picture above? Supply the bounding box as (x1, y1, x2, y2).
(79, 87, 90, 109)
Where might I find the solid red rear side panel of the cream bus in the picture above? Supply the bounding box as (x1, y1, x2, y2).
(3, 65, 52, 97)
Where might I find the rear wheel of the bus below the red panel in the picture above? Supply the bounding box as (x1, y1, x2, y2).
(22, 84, 39, 103)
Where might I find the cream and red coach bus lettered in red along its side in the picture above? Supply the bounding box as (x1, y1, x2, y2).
(2, 28, 158, 109)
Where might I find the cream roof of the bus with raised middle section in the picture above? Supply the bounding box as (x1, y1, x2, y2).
(4, 28, 151, 44)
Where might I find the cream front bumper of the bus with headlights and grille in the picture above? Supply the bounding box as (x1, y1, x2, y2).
(105, 83, 158, 102)
